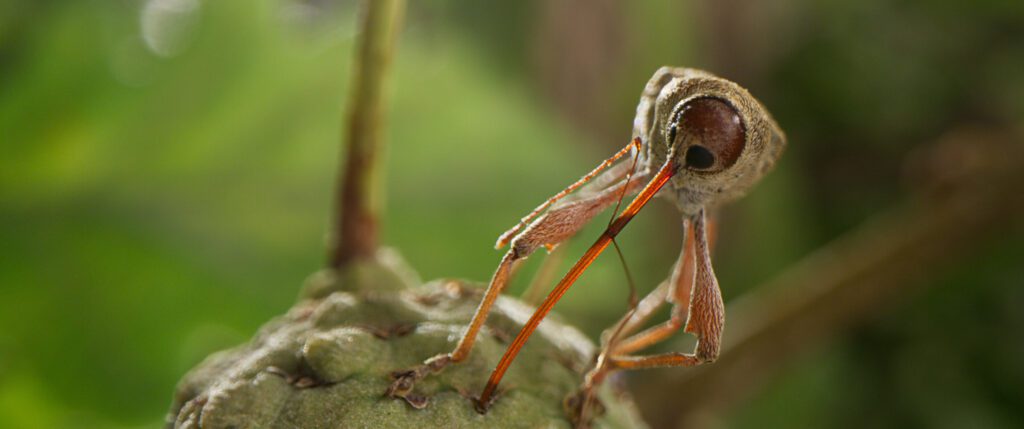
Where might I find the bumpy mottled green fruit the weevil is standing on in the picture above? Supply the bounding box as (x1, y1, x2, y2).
(168, 249, 644, 428)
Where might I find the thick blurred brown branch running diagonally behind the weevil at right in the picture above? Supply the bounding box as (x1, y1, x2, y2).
(636, 127, 1024, 427)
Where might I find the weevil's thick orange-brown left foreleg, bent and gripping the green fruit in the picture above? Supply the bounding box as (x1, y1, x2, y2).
(387, 139, 643, 397)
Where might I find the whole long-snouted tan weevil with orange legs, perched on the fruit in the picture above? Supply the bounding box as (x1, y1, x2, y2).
(387, 67, 785, 413)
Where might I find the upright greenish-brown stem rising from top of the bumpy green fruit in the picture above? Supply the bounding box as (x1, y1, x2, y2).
(328, 0, 406, 268)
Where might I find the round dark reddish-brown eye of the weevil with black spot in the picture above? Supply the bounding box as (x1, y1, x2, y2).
(674, 97, 746, 172)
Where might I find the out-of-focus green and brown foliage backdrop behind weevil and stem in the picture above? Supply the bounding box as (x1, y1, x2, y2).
(0, 0, 1024, 428)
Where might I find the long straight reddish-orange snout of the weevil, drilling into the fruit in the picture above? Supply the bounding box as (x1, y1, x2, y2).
(476, 156, 678, 413)
